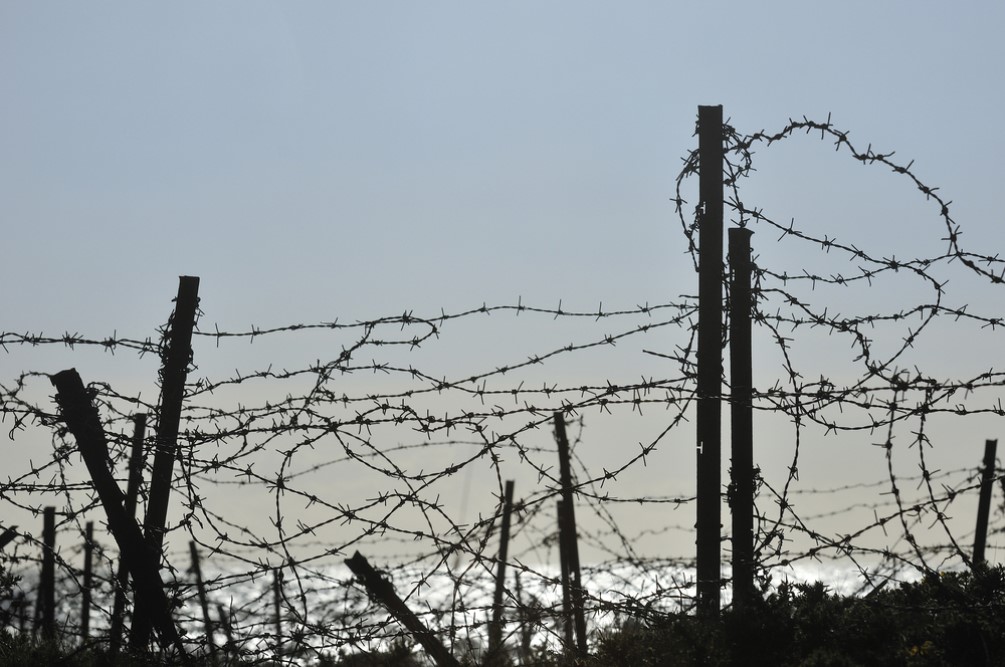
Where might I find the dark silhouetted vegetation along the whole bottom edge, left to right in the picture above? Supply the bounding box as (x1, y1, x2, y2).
(0, 566, 1005, 667)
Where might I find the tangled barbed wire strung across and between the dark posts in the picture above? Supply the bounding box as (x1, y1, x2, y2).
(0, 106, 1005, 664)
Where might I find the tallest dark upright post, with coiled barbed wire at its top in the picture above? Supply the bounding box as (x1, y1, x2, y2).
(696, 101, 724, 615)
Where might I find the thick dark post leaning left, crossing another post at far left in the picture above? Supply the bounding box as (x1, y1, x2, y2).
(49, 369, 188, 662)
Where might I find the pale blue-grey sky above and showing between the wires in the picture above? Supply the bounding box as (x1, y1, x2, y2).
(0, 0, 1005, 582)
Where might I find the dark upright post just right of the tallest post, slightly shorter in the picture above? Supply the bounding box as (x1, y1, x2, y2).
(729, 227, 754, 610)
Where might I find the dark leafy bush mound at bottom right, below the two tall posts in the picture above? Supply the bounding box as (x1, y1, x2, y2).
(588, 566, 1005, 667)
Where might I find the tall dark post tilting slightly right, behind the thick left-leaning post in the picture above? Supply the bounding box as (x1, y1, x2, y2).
(136, 275, 199, 648)
